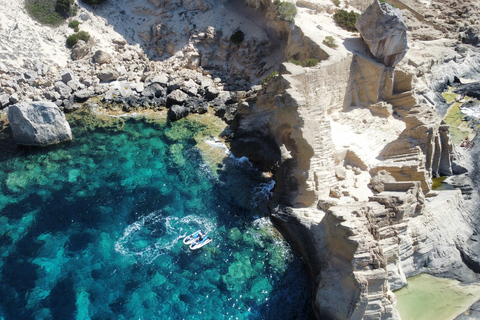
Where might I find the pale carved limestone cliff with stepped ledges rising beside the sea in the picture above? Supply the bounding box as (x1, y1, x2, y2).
(232, 3, 476, 319)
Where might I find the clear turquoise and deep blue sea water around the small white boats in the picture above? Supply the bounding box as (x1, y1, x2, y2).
(0, 109, 311, 320)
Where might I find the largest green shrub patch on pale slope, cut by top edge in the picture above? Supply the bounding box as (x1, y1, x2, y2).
(25, 0, 76, 26)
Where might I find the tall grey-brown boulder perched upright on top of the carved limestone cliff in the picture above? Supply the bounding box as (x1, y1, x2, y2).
(355, 0, 408, 67)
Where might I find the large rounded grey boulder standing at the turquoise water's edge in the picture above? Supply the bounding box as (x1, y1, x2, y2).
(8, 101, 72, 146)
